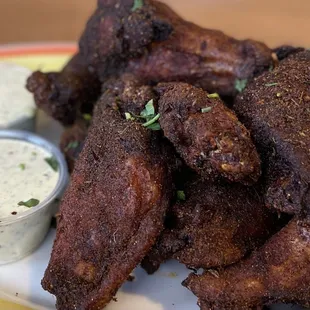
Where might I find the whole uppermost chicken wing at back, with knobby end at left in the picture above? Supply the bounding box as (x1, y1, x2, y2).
(28, 0, 273, 125)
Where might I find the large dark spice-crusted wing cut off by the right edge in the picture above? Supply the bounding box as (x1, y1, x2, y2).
(234, 51, 310, 214)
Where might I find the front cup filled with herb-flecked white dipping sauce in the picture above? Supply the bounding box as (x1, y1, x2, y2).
(0, 139, 60, 264)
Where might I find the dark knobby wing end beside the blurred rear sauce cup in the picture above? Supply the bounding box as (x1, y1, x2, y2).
(27, 54, 101, 125)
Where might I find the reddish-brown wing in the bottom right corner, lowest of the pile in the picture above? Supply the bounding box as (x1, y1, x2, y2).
(183, 220, 310, 310)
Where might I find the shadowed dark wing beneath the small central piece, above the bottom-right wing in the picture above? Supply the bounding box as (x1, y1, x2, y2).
(142, 180, 276, 273)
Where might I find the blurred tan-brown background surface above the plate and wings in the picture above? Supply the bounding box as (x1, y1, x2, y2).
(0, 0, 310, 47)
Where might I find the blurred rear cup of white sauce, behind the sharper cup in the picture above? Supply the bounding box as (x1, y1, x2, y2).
(0, 62, 36, 129)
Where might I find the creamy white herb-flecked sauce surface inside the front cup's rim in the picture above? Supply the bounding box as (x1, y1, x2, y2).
(0, 139, 59, 220)
